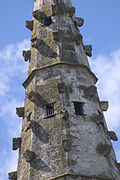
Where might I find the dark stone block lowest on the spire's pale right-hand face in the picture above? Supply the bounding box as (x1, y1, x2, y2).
(97, 144, 111, 156)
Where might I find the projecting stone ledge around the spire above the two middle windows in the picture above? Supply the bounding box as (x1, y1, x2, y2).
(22, 63, 98, 88)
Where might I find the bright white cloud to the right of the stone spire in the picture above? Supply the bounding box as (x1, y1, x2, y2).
(90, 50, 120, 129)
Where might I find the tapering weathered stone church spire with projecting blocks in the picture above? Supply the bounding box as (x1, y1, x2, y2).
(9, 0, 120, 180)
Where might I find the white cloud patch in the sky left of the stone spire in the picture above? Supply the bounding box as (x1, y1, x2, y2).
(0, 40, 30, 180)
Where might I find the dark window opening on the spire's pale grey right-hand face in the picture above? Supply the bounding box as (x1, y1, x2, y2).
(73, 102, 84, 115)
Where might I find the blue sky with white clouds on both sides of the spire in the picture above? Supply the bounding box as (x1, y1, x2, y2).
(0, 0, 120, 180)
